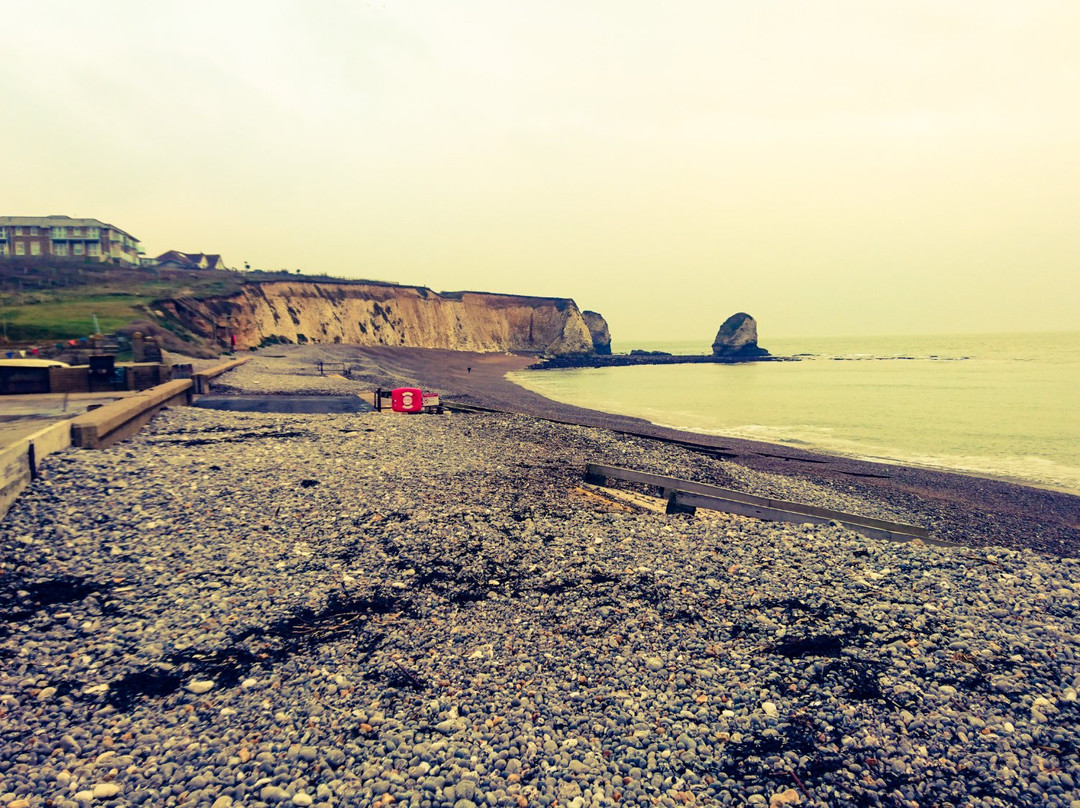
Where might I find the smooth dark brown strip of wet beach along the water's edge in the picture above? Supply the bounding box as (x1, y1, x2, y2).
(352, 346, 1080, 556)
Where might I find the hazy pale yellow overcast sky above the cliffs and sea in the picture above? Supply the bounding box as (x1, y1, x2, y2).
(0, 0, 1080, 347)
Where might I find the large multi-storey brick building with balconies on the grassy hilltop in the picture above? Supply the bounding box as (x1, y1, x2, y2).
(0, 216, 140, 266)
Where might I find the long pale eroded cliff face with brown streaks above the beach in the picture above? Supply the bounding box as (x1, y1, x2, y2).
(172, 281, 593, 355)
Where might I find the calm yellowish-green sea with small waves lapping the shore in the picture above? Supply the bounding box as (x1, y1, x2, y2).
(510, 332, 1080, 494)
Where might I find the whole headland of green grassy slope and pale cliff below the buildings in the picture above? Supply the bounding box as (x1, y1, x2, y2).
(0, 262, 610, 355)
